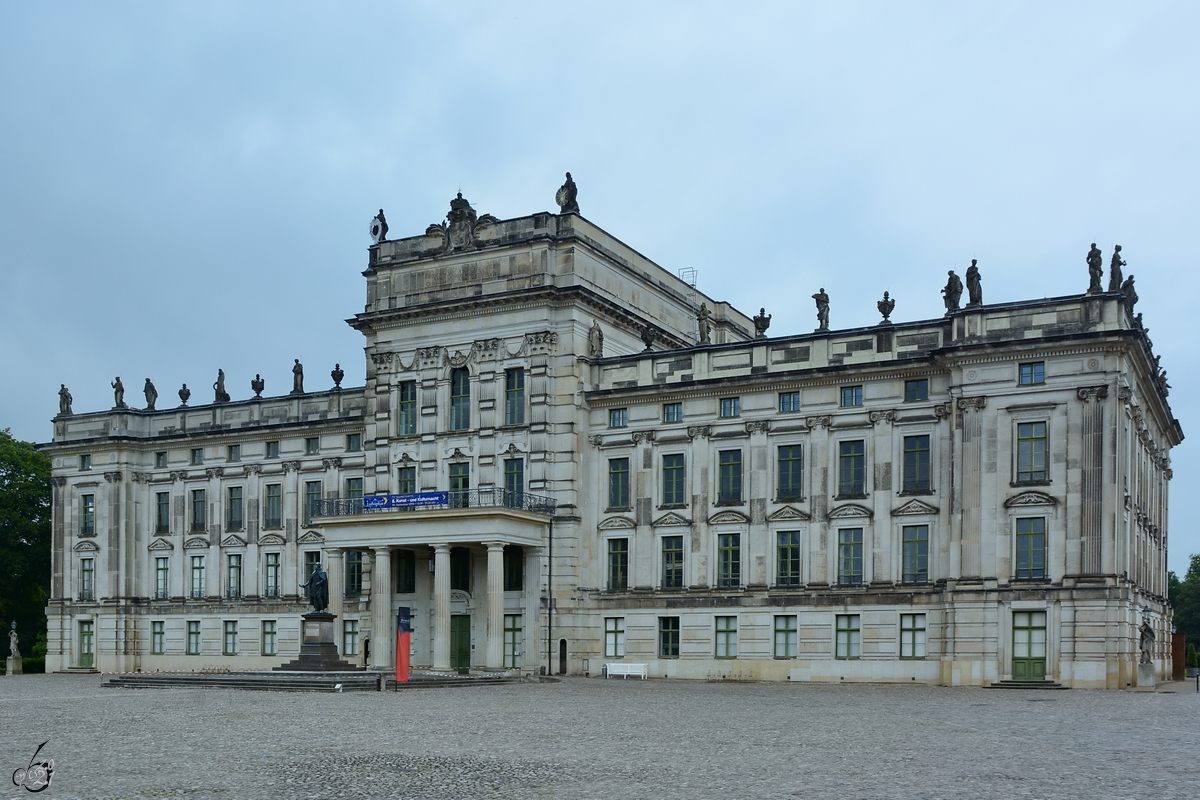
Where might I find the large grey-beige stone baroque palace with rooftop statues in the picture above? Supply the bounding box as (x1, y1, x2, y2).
(43, 175, 1183, 688)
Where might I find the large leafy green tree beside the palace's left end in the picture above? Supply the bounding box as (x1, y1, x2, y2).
(0, 428, 50, 656)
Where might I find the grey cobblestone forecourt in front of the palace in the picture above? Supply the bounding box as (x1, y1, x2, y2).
(0, 675, 1200, 800)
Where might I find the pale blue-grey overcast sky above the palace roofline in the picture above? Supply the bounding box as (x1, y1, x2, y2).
(0, 0, 1200, 573)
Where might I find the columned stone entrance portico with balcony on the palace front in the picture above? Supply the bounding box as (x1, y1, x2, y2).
(312, 493, 553, 672)
